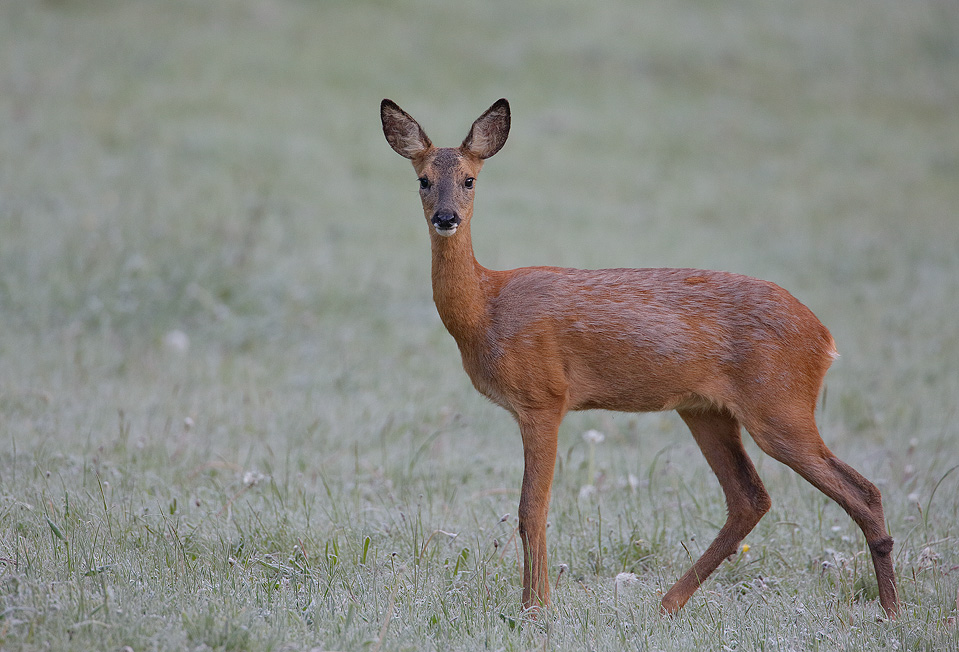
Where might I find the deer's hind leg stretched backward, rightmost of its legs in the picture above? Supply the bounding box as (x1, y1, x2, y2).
(746, 411, 899, 618)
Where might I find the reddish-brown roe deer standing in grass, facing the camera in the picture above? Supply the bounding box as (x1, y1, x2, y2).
(380, 95, 899, 617)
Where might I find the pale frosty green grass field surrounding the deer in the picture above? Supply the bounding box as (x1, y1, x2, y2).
(0, 0, 959, 652)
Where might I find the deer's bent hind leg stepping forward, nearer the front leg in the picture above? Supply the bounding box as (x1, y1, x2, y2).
(662, 410, 771, 613)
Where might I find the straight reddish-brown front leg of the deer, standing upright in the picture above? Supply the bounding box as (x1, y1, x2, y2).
(517, 413, 562, 612)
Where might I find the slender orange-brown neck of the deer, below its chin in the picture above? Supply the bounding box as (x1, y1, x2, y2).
(430, 224, 489, 344)
